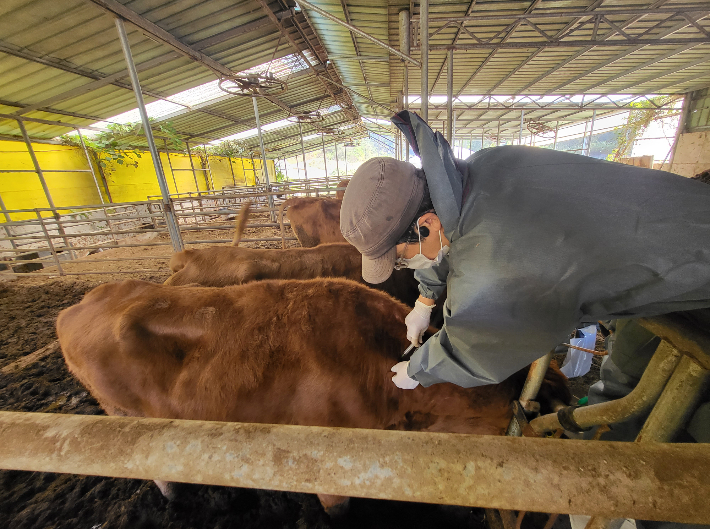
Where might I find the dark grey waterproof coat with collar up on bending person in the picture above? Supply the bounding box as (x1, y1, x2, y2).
(393, 111, 710, 387)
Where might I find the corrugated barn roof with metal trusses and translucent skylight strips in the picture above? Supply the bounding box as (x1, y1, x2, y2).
(0, 0, 710, 157)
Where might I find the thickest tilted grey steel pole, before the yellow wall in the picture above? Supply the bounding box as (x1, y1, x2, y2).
(116, 18, 185, 255)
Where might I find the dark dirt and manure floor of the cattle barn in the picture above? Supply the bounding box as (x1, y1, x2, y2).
(0, 216, 599, 528)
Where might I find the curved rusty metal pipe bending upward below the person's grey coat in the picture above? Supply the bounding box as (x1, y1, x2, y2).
(530, 341, 681, 434)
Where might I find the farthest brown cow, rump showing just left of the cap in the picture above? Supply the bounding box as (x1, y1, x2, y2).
(279, 198, 345, 249)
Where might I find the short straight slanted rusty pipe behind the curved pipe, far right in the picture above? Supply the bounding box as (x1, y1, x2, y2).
(636, 356, 710, 442)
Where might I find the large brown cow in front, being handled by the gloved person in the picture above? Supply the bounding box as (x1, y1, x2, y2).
(57, 279, 570, 516)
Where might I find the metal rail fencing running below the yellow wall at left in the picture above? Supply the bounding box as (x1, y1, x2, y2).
(0, 176, 349, 277)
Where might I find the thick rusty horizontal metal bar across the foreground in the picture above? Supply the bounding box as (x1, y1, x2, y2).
(0, 412, 710, 524)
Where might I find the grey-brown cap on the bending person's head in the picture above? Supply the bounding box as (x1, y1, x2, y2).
(340, 157, 425, 284)
